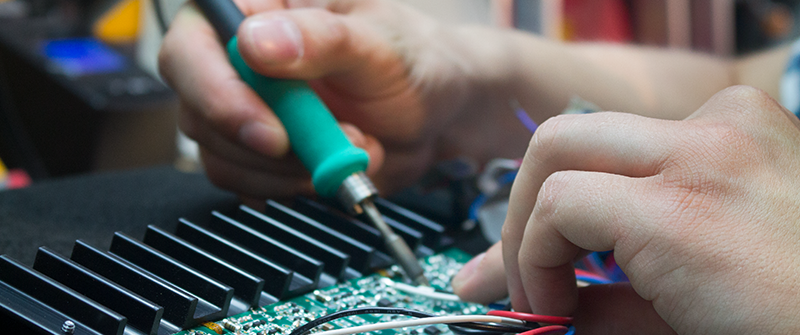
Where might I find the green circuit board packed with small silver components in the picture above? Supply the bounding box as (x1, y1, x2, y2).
(178, 249, 488, 335)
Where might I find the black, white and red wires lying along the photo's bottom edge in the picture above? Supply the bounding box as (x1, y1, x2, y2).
(289, 307, 572, 335)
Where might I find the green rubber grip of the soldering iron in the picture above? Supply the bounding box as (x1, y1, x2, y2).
(227, 37, 369, 198)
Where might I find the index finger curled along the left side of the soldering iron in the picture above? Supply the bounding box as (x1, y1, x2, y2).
(159, 6, 289, 157)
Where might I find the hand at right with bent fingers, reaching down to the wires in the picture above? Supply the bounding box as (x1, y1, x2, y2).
(453, 86, 800, 334)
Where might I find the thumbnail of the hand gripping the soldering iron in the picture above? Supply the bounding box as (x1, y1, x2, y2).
(245, 17, 303, 64)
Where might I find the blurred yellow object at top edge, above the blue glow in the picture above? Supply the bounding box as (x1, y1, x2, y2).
(93, 0, 142, 43)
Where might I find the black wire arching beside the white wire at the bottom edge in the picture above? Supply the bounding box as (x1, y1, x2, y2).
(289, 307, 531, 335)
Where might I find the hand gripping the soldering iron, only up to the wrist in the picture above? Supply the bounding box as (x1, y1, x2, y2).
(159, 0, 494, 199)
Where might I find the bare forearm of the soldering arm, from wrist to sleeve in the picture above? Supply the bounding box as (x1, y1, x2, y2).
(442, 27, 788, 162)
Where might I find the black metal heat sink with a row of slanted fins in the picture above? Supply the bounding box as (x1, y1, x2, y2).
(0, 198, 444, 335)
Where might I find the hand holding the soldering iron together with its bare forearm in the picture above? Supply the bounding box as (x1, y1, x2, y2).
(159, 0, 782, 200)
